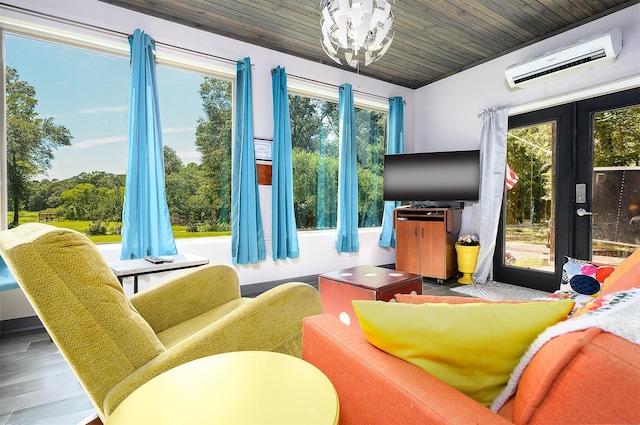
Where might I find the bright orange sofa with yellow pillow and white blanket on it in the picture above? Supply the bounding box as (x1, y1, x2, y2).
(302, 250, 640, 425)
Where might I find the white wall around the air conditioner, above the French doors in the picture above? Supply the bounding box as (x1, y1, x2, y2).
(416, 4, 640, 233)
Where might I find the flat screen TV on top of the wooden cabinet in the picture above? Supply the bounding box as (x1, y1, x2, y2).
(383, 150, 480, 206)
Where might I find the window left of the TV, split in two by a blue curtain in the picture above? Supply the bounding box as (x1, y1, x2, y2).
(289, 94, 388, 230)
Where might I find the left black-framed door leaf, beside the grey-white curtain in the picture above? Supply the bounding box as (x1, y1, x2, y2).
(493, 105, 575, 292)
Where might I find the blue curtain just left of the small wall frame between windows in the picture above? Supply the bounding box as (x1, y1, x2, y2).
(231, 58, 266, 264)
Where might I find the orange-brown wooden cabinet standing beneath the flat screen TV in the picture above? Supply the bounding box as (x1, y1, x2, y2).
(393, 207, 462, 282)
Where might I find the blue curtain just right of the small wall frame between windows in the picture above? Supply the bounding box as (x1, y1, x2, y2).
(271, 67, 300, 261)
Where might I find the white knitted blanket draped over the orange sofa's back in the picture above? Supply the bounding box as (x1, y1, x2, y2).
(491, 288, 640, 412)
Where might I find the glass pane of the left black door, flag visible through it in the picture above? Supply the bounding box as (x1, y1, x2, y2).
(504, 121, 557, 273)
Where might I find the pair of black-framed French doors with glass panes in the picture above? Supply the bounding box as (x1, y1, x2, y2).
(494, 89, 640, 292)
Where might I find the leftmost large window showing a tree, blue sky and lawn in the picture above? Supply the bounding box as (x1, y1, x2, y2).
(5, 34, 129, 240)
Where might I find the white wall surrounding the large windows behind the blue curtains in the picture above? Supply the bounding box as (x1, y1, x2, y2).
(0, 0, 414, 320)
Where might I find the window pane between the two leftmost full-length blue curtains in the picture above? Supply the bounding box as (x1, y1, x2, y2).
(158, 66, 232, 234)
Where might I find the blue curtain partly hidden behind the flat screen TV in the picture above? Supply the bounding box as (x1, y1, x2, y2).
(378, 96, 404, 248)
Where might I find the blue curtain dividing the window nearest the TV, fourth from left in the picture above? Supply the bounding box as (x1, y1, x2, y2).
(336, 84, 359, 252)
